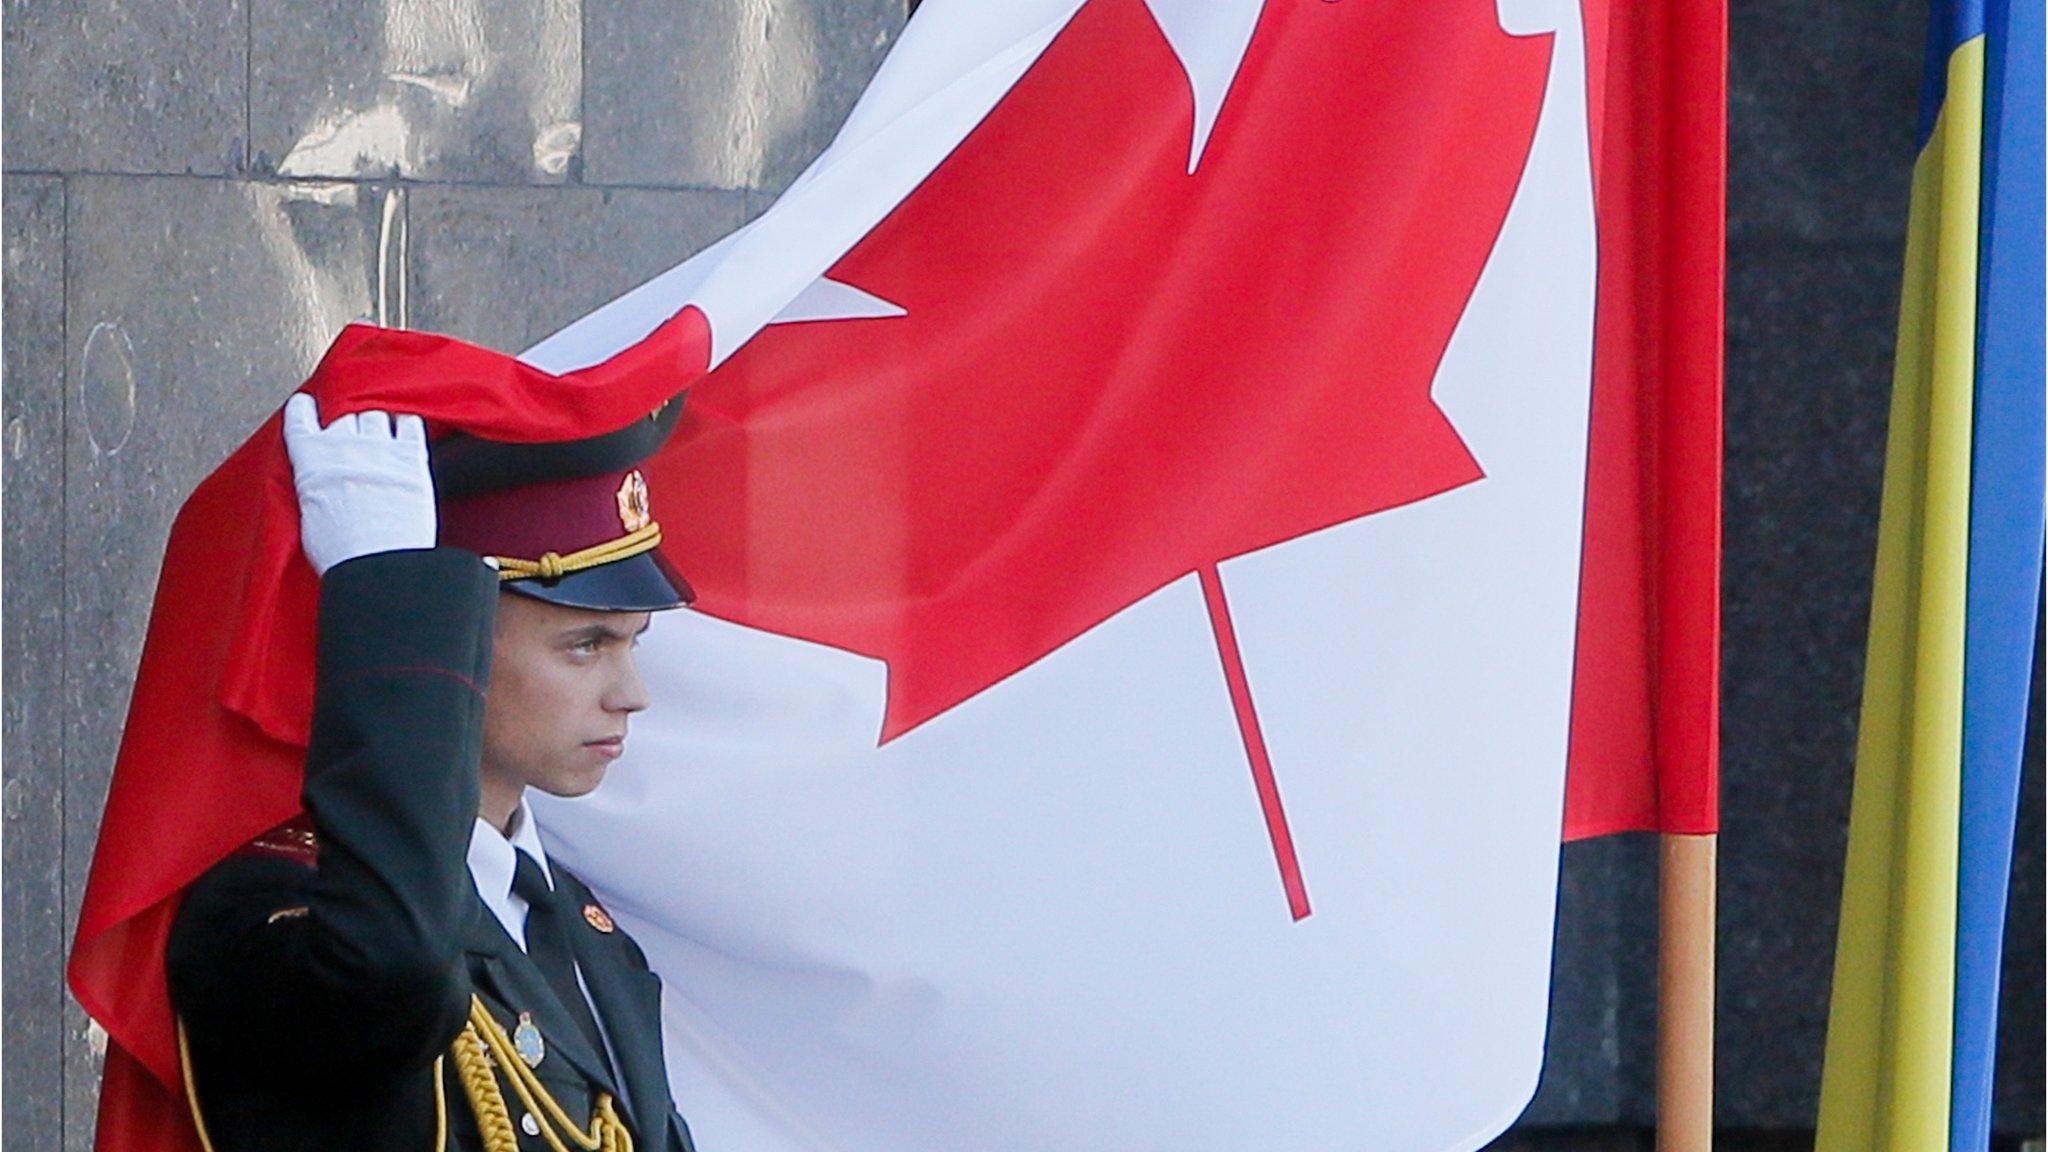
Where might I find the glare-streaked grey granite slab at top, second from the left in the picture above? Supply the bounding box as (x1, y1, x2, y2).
(250, 0, 584, 184)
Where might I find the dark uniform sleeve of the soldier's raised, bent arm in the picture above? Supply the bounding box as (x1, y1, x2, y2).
(168, 549, 498, 1082)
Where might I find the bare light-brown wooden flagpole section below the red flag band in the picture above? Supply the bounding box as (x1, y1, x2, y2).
(1657, 834, 1718, 1152)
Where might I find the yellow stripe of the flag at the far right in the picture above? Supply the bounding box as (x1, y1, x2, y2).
(1817, 37, 1985, 1152)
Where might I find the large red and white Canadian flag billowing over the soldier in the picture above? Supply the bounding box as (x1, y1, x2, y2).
(74, 0, 1720, 1152)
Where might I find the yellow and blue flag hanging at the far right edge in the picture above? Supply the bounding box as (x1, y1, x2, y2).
(1817, 0, 2044, 1152)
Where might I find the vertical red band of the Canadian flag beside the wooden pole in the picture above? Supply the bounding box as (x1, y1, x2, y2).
(1565, 4, 1729, 840)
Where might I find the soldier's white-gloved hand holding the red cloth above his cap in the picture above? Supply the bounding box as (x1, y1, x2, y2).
(285, 392, 438, 576)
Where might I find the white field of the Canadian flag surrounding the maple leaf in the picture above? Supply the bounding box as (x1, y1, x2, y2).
(537, 0, 1595, 1152)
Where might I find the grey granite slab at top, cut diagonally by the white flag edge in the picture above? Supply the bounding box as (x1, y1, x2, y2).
(584, 0, 903, 191)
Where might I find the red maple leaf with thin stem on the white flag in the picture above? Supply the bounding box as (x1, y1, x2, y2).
(655, 0, 1550, 914)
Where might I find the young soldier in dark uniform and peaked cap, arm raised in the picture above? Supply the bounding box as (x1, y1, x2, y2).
(168, 396, 690, 1152)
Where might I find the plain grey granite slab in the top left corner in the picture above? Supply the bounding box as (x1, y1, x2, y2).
(0, 0, 248, 174)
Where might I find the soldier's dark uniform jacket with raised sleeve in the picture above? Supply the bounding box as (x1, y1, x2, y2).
(168, 549, 690, 1152)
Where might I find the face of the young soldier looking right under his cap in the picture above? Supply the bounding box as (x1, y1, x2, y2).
(483, 592, 647, 814)
